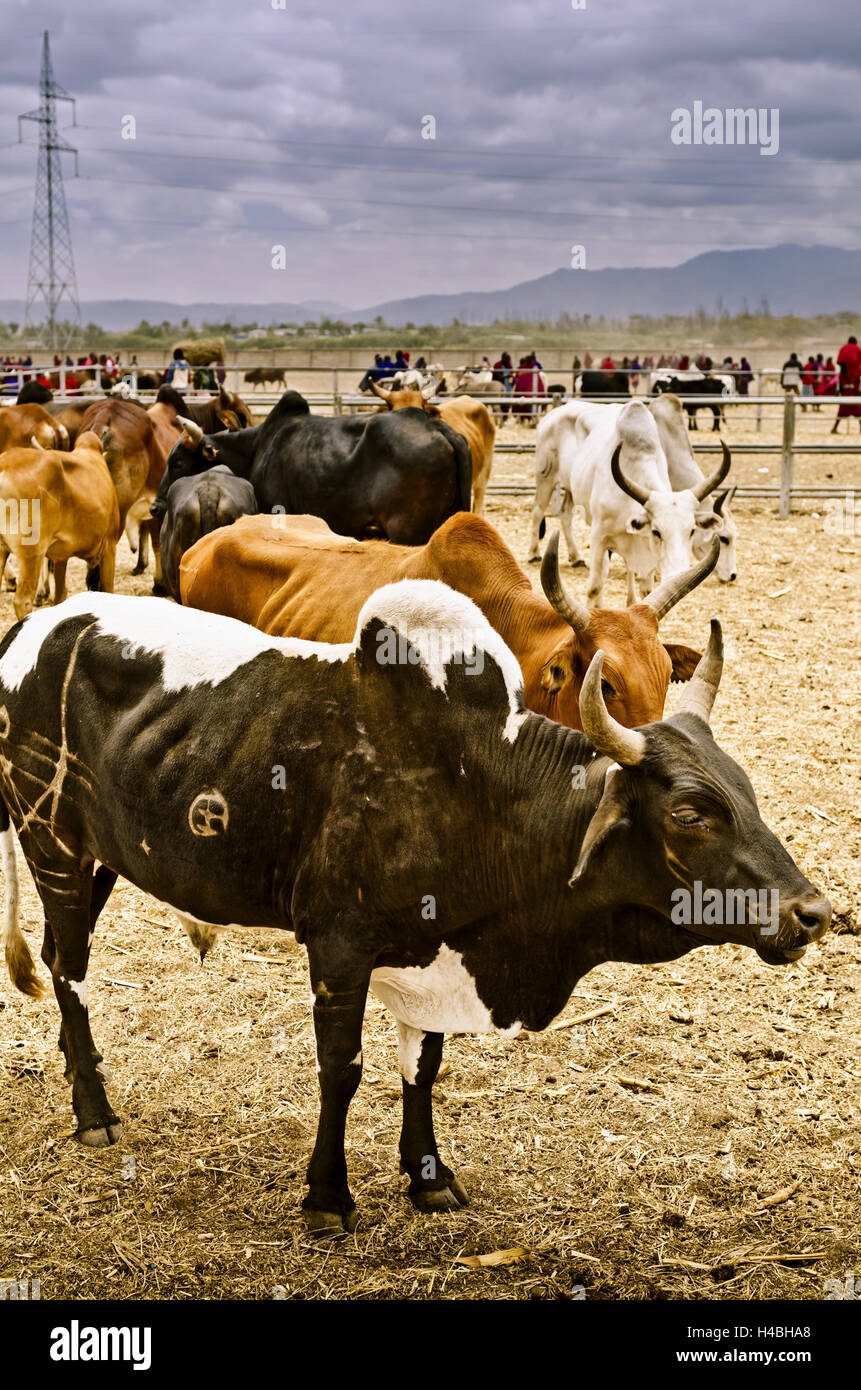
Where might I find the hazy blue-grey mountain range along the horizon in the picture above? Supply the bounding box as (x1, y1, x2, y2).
(0, 245, 861, 332)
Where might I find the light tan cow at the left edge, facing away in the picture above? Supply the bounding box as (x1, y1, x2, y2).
(0, 431, 121, 619)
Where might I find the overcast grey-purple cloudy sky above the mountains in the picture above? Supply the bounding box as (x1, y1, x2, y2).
(0, 0, 861, 309)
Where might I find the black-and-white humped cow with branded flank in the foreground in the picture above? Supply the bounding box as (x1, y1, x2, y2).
(0, 580, 830, 1232)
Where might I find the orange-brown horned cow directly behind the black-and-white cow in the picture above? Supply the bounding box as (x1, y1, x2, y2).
(179, 512, 719, 728)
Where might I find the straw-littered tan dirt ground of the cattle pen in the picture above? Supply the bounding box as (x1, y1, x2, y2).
(0, 397, 861, 1300)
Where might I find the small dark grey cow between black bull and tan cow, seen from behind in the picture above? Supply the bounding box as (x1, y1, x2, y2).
(160, 464, 257, 603)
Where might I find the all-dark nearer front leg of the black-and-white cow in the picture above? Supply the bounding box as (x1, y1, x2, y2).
(302, 941, 373, 1234)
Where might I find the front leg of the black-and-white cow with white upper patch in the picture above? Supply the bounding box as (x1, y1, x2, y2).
(398, 1020, 469, 1212)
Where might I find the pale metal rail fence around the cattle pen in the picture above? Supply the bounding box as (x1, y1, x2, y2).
(10, 364, 861, 520)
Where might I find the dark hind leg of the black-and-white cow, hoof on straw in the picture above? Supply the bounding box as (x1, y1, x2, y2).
(37, 862, 122, 1148)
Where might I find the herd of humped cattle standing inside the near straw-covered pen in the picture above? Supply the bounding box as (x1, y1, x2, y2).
(0, 375, 830, 1233)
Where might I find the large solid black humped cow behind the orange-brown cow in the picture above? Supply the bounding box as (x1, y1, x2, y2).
(153, 391, 473, 545)
